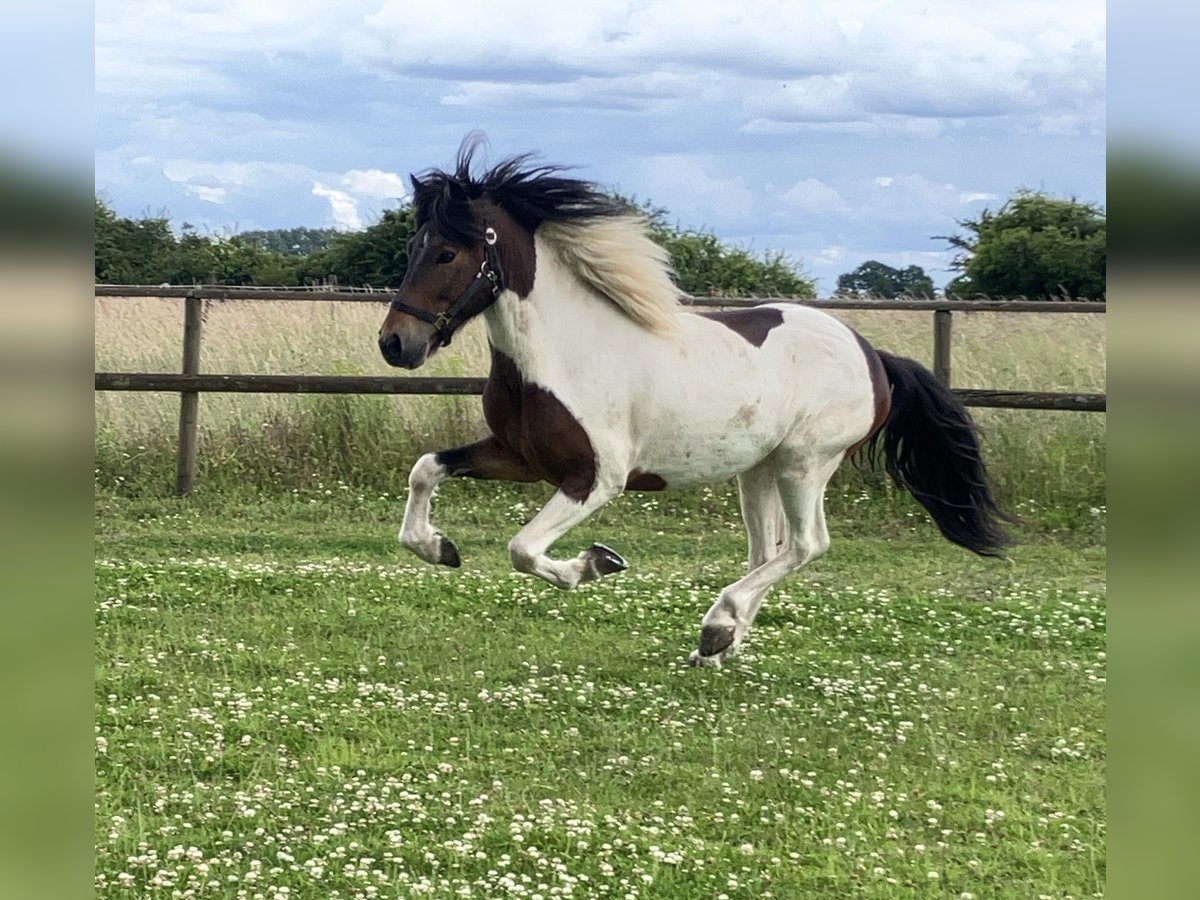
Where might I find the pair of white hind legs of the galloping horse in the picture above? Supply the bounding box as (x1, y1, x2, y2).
(689, 454, 841, 666)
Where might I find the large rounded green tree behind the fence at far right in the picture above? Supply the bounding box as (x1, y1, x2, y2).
(941, 191, 1106, 300)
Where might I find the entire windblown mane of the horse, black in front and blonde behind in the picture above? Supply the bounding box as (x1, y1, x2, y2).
(410, 133, 680, 331)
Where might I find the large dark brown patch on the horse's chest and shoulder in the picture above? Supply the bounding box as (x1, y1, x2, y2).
(484, 347, 596, 503)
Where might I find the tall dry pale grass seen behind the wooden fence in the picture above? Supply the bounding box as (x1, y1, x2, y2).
(96, 298, 1105, 525)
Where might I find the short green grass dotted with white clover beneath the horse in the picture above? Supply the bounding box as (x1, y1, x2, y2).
(96, 487, 1105, 900)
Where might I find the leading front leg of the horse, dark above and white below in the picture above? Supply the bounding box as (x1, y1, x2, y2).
(400, 437, 539, 568)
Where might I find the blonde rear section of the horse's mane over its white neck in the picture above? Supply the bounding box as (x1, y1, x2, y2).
(538, 215, 680, 334)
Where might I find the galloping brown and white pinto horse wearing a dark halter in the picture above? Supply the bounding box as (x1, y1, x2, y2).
(379, 138, 1012, 666)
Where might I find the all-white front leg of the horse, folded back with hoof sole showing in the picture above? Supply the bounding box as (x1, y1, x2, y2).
(509, 480, 629, 590)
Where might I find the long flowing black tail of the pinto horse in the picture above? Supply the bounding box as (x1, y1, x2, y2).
(868, 352, 1014, 557)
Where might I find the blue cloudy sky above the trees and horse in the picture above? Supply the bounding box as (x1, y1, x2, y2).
(94, 0, 1106, 294)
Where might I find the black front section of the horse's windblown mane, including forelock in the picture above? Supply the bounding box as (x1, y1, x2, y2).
(409, 134, 629, 245)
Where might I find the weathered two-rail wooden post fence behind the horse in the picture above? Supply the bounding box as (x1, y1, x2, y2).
(96, 284, 1108, 494)
